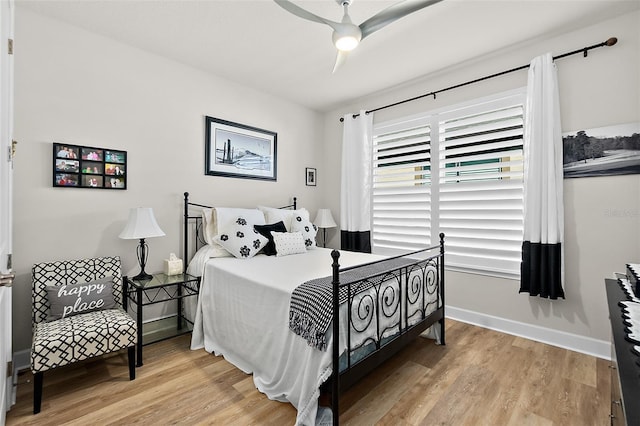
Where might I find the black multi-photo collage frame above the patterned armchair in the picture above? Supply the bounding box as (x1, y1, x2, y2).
(53, 142, 127, 190)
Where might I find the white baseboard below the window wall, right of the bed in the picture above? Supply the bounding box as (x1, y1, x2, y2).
(445, 306, 611, 360)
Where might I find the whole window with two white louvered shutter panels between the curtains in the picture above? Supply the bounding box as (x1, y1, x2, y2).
(372, 89, 525, 277)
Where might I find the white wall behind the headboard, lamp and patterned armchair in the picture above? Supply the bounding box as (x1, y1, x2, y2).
(14, 7, 323, 351)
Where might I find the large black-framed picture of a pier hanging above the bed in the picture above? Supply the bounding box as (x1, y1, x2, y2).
(204, 116, 278, 181)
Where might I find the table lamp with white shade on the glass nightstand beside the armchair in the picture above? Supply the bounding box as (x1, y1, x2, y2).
(119, 207, 165, 280)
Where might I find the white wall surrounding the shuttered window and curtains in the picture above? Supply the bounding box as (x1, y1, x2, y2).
(322, 12, 640, 356)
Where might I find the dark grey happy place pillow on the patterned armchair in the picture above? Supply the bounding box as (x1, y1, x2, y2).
(47, 277, 116, 321)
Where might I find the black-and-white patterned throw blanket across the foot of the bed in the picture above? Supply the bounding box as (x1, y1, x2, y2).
(289, 258, 419, 351)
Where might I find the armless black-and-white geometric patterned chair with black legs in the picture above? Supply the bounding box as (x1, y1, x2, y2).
(31, 256, 137, 414)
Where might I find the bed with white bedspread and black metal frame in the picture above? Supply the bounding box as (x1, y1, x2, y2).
(184, 192, 445, 425)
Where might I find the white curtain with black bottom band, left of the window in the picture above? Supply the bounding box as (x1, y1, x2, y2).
(340, 111, 373, 252)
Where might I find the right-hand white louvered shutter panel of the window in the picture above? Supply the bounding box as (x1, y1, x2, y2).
(439, 97, 524, 274)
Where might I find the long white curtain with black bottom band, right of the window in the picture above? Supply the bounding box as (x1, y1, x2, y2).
(520, 53, 564, 299)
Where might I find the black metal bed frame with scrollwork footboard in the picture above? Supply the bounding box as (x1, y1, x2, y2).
(183, 192, 445, 425)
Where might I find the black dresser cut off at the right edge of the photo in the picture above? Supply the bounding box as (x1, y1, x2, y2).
(605, 279, 640, 426)
